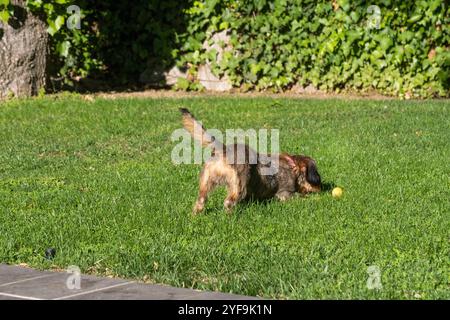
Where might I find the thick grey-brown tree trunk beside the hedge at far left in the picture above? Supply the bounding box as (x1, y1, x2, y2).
(0, 0, 48, 98)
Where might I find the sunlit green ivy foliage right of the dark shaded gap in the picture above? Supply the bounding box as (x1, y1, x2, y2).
(176, 0, 450, 97)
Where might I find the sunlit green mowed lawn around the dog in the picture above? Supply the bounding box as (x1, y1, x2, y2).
(0, 96, 450, 299)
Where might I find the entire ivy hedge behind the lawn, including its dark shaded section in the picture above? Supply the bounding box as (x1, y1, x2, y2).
(0, 0, 450, 97)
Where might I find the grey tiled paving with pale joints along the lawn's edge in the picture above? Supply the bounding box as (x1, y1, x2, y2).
(0, 264, 256, 300)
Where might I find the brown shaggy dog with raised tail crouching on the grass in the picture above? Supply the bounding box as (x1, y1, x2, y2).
(179, 108, 321, 214)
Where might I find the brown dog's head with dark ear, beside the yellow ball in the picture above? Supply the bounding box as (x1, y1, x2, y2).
(285, 155, 321, 194)
